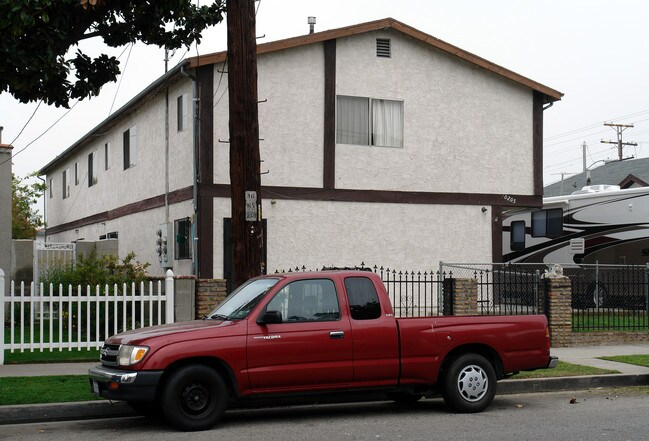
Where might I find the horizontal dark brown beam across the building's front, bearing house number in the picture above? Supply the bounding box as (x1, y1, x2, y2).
(203, 184, 543, 207)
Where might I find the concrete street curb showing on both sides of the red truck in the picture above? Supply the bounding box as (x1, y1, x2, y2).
(0, 374, 649, 426)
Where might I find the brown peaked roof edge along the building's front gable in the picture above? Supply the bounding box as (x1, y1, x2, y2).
(189, 18, 563, 104)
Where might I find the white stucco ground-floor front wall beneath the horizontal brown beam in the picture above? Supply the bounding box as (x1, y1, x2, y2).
(214, 199, 492, 278)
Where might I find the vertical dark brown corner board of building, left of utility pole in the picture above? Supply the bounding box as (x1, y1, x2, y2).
(196, 65, 214, 279)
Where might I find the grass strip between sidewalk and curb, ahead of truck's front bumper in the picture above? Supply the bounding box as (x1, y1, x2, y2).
(0, 375, 97, 406)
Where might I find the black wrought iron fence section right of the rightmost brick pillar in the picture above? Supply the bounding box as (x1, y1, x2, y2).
(564, 264, 649, 332)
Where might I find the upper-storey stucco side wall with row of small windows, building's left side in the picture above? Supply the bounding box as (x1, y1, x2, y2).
(46, 79, 193, 227)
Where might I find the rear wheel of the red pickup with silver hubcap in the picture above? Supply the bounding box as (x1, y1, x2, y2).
(441, 353, 496, 413)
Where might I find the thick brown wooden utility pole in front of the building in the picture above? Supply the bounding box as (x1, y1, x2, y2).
(226, 0, 264, 287)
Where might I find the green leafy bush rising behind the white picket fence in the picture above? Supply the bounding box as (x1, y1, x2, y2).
(40, 251, 150, 287)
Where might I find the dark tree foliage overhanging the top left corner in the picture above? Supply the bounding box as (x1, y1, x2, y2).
(0, 0, 225, 107)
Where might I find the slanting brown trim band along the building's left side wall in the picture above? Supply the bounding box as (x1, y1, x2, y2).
(47, 187, 193, 234)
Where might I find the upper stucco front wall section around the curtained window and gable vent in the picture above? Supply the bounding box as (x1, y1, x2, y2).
(336, 31, 533, 194)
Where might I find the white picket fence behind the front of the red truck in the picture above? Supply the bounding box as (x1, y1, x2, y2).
(0, 269, 174, 365)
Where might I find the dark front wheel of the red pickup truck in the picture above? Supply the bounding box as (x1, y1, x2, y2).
(161, 364, 228, 431)
